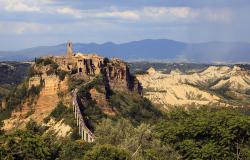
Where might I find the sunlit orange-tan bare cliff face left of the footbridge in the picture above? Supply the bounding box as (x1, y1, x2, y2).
(4, 61, 70, 130)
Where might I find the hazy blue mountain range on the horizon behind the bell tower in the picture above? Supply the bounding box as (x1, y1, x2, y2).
(0, 39, 250, 63)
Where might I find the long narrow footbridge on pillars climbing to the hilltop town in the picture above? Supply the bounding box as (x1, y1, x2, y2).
(72, 89, 95, 142)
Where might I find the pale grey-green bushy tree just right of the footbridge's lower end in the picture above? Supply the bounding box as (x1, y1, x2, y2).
(95, 119, 180, 160)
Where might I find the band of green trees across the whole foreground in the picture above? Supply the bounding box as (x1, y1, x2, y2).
(0, 105, 250, 160)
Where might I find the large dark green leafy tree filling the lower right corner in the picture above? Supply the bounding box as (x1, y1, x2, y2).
(156, 108, 250, 159)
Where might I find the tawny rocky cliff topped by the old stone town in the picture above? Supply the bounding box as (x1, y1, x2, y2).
(1, 46, 142, 130)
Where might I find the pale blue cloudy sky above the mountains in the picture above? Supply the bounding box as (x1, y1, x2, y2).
(0, 0, 250, 50)
